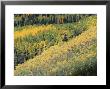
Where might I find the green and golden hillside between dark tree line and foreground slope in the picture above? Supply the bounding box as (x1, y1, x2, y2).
(14, 16, 96, 67)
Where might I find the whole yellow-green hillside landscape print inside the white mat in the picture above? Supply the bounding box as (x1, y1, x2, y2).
(14, 14, 97, 76)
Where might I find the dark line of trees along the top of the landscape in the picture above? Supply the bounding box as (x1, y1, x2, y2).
(14, 14, 93, 27)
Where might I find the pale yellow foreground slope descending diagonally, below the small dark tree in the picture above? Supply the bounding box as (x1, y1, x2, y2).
(14, 25, 97, 76)
